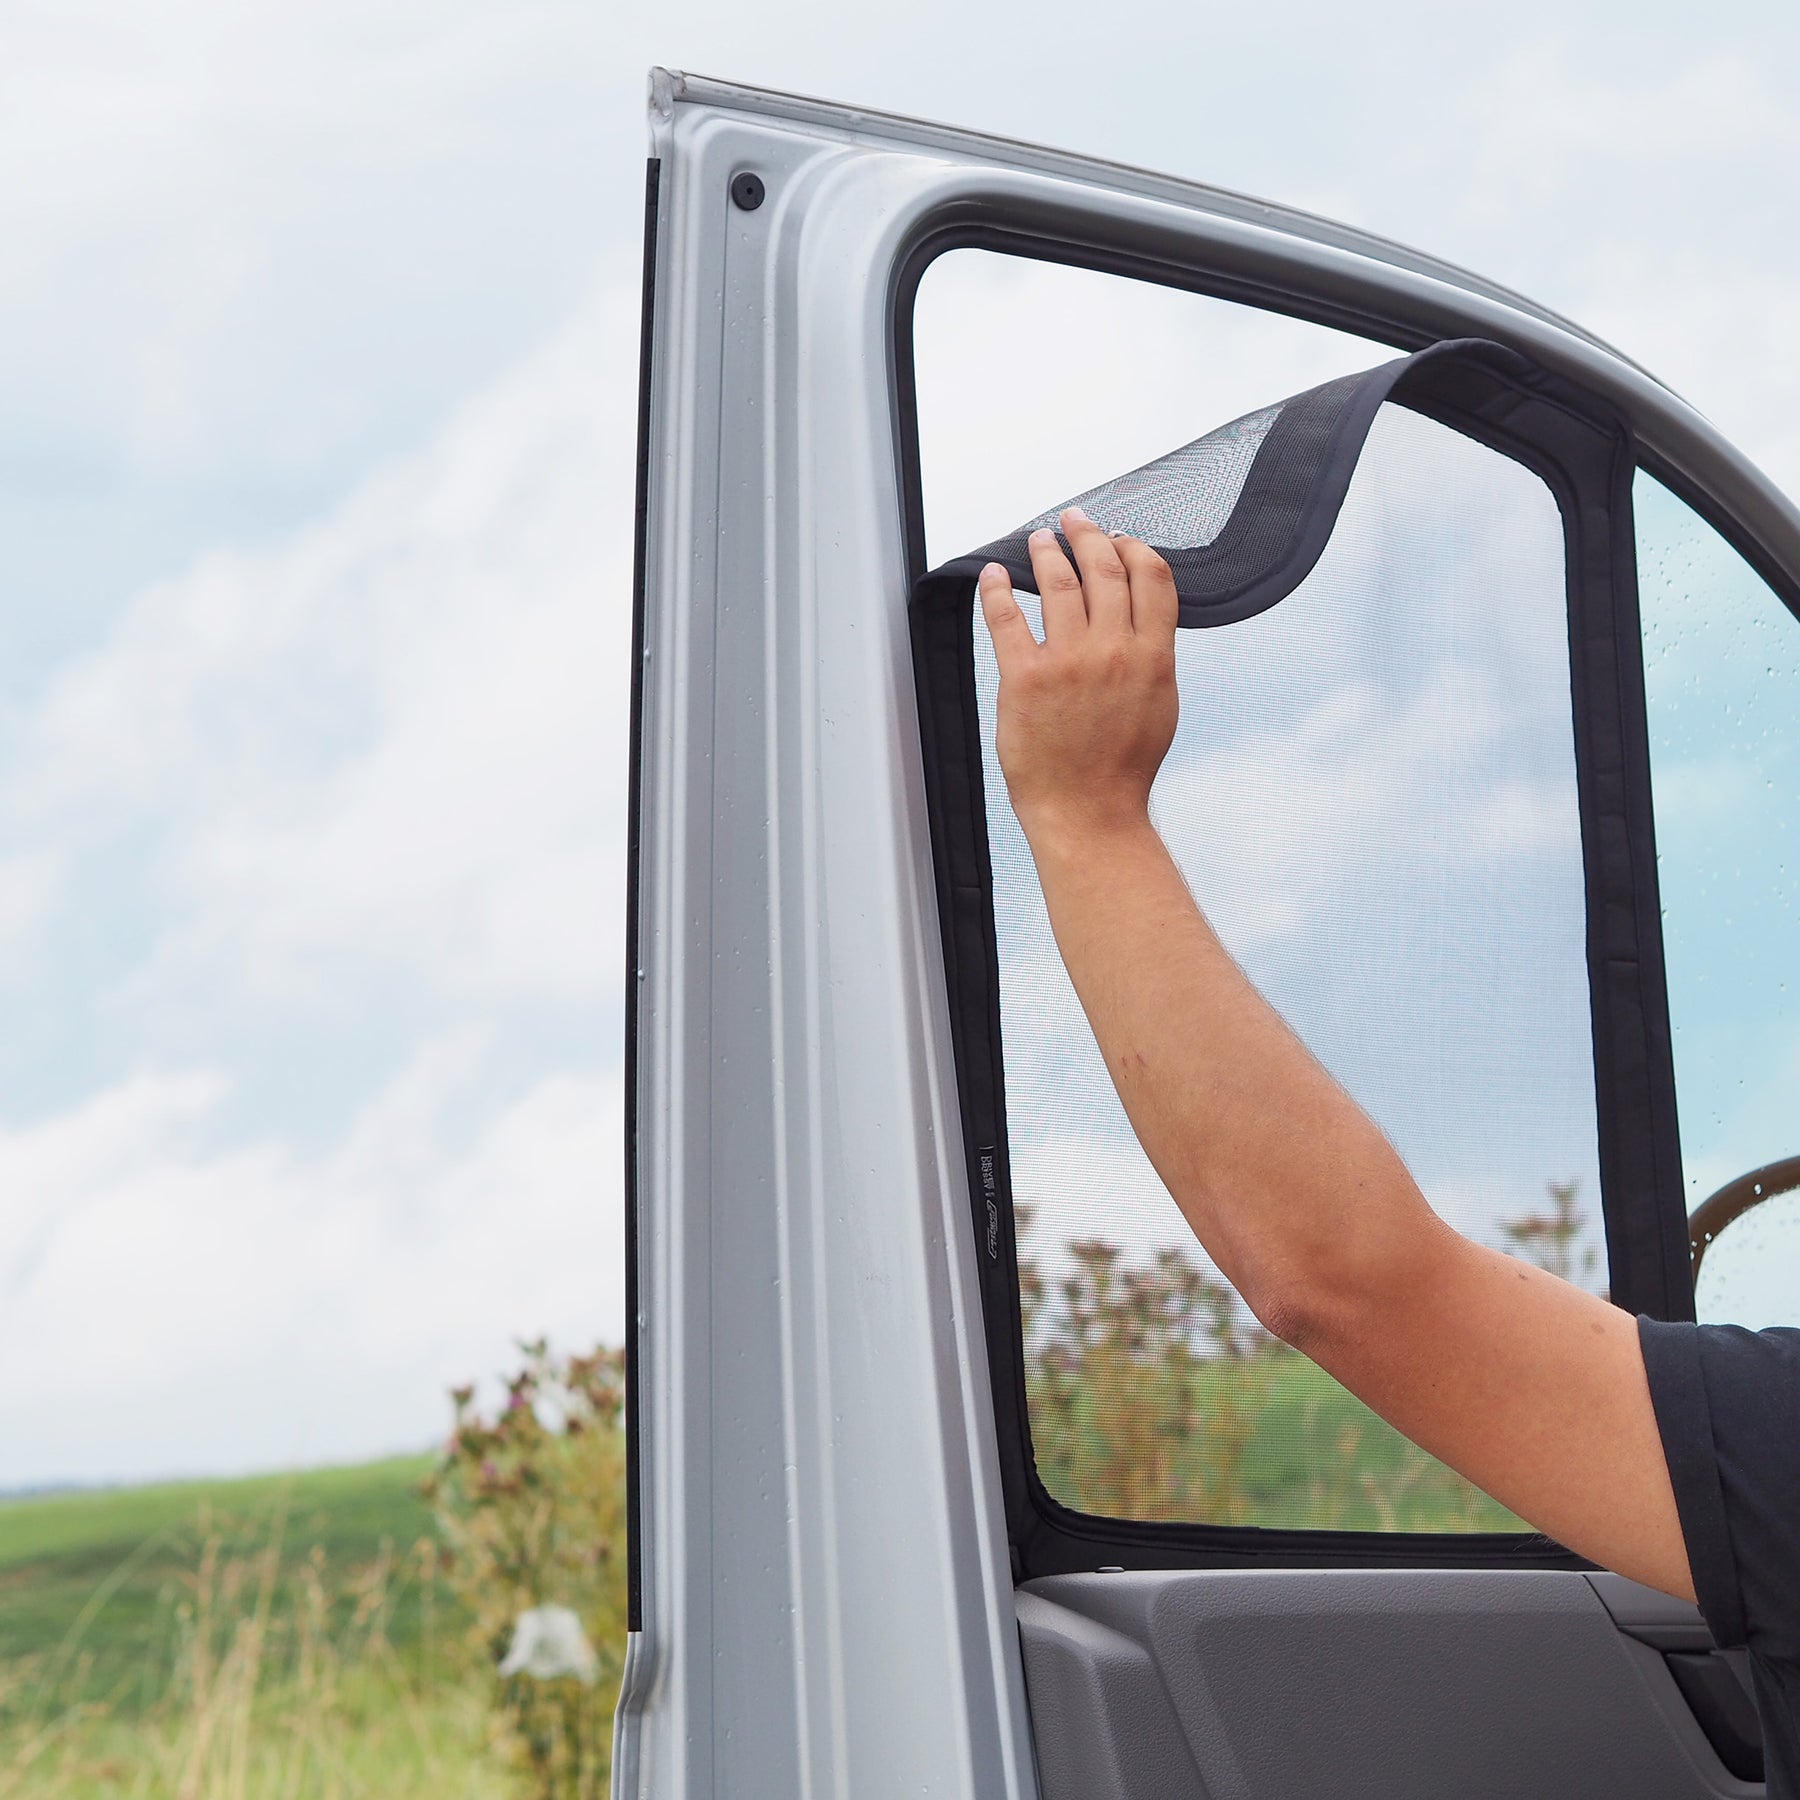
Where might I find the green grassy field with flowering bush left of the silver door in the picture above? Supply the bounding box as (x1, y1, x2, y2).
(0, 1343, 625, 1800)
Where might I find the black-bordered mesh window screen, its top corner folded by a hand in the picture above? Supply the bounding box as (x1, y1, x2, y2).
(913, 340, 1685, 1573)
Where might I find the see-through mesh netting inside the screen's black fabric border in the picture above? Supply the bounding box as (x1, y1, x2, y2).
(970, 405, 1607, 1532)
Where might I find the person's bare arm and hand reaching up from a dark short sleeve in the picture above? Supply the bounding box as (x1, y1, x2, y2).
(981, 511, 1692, 1597)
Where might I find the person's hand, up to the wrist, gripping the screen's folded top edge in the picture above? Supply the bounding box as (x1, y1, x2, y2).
(981, 506, 1179, 855)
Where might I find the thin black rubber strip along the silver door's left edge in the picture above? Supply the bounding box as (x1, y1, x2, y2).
(625, 157, 662, 1631)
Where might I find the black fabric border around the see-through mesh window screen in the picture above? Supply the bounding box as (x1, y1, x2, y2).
(895, 331, 1692, 1579)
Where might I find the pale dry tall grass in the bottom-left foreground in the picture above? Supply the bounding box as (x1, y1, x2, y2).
(0, 1514, 509, 1800)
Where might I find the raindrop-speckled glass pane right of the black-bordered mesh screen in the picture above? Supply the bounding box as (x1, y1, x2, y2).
(1633, 473, 1800, 1327)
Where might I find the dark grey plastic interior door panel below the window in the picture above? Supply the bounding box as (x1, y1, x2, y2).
(1019, 1570, 1762, 1800)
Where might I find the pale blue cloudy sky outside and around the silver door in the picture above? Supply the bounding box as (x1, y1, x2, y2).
(0, 0, 1800, 1489)
